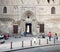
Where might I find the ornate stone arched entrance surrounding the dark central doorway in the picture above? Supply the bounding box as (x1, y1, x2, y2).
(21, 10, 37, 35)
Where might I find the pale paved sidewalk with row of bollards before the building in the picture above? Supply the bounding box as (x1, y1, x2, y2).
(0, 37, 60, 52)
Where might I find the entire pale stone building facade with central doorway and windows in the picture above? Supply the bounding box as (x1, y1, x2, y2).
(0, 0, 60, 35)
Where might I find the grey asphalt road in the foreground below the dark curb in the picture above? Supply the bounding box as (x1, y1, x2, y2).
(12, 45, 60, 52)
